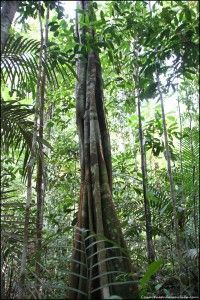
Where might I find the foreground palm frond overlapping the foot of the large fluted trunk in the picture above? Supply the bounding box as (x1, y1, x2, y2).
(68, 228, 136, 299)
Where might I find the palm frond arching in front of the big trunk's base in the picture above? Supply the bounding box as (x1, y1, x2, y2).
(68, 228, 137, 299)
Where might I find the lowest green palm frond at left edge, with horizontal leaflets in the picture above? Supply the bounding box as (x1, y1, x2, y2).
(0, 171, 35, 298)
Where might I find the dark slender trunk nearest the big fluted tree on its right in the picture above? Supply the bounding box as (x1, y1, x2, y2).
(134, 45, 155, 263)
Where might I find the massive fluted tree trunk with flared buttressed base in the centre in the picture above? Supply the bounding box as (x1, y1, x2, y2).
(69, 1, 137, 299)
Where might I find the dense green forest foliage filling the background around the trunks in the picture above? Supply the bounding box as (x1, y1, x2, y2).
(1, 1, 199, 299)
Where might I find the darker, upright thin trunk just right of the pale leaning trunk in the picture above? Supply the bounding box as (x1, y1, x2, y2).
(35, 6, 49, 299)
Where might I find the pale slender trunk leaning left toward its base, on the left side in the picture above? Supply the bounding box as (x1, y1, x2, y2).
(18, 7, 43, 299)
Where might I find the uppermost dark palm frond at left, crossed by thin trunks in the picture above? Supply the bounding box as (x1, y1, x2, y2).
(1, 35, 74, 94)
